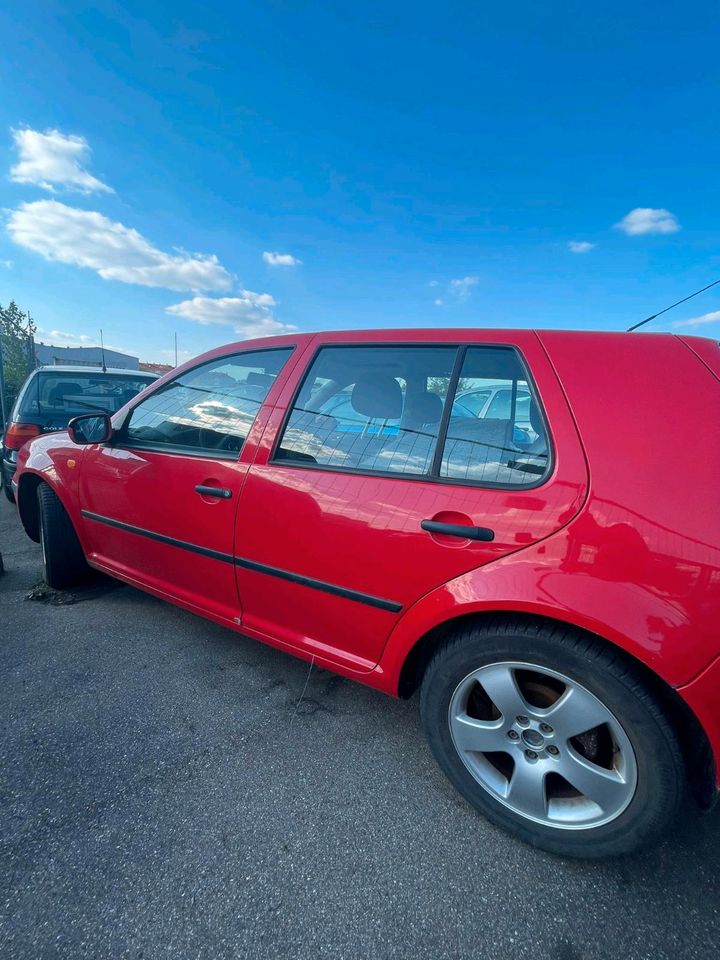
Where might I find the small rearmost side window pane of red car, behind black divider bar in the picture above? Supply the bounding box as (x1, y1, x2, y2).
(440, 347, 549, 487)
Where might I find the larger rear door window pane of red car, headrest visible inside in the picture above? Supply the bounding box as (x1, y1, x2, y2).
(275, 346, 457, 475)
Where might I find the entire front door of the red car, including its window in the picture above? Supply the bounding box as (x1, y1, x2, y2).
(80, 347, 293, 620)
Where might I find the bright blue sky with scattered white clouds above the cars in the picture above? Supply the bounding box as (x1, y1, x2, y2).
(0, 0, 720, 360)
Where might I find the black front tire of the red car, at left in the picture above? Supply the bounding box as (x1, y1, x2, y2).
(37, 483, 90, 590)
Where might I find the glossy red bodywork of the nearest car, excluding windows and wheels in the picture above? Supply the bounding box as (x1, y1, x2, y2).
(17, 330, 720, 784)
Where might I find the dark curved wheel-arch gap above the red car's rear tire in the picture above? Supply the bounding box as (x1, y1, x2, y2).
(397, 610, 715, 807)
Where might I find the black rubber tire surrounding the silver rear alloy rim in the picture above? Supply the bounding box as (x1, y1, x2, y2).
(420, 617, 687, 858)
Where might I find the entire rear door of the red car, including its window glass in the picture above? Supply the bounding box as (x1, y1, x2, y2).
(236, 332, 587, 671)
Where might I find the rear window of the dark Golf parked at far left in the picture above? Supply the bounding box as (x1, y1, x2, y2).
(15, 367, 157, 429)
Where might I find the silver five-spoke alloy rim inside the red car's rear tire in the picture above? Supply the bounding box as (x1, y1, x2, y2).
(448, 661, 637, 830)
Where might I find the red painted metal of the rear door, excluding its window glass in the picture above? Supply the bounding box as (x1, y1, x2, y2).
(236, 331, 587, 671)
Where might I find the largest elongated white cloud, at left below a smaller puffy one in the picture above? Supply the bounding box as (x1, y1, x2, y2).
(7, 200, 233, 291)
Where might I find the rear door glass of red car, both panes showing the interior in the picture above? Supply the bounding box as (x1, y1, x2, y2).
(275, 346, 548, 485)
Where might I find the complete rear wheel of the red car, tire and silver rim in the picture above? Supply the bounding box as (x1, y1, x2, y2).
(420, 618, 686, 858)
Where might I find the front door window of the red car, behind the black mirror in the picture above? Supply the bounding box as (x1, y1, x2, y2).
(124, 348, 292, 456)
